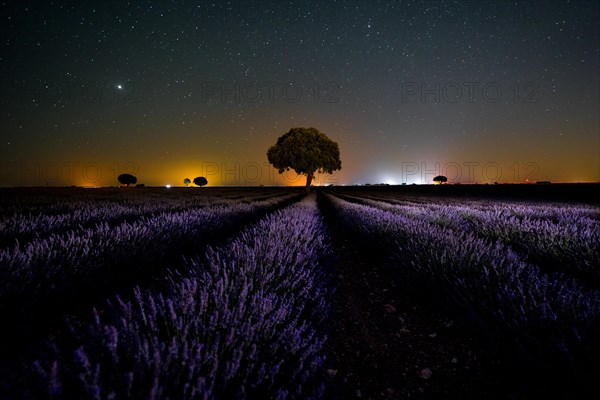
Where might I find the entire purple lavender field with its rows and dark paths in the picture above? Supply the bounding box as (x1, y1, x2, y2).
(0, 187, 600, 399)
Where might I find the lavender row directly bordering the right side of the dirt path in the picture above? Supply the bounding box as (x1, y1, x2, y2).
(328, 196, 600, 394)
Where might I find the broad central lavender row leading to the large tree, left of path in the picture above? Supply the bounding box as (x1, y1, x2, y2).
(30, 196, 330, 399)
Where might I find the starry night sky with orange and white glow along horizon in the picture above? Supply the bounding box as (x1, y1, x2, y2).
(0, 0, 600, 186)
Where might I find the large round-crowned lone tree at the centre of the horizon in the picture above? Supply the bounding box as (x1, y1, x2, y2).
(267, 128, 342, 193)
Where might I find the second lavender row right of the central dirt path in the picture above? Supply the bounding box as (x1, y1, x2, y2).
(332, 191, 600, 289)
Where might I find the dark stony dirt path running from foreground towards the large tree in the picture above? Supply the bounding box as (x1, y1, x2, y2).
(319, 195, 496, 399)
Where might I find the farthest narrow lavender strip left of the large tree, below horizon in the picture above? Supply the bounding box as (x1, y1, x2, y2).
(0, 189, 292, 248)
